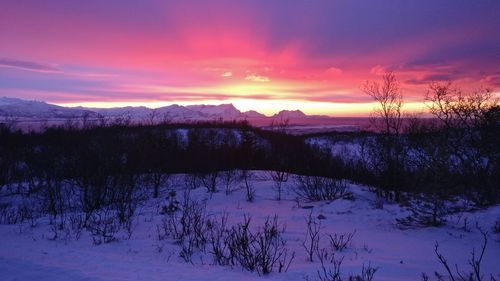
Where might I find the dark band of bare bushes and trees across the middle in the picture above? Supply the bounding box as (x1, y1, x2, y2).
(0, 76, 500, 234)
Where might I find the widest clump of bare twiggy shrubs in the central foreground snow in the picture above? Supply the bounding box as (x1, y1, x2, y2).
(157, 207, 295, 275)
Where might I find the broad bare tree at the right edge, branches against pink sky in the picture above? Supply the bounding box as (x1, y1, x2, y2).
(426, 82, 500, 204)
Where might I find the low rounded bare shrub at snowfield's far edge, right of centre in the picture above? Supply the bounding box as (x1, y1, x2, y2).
(295, 176, 350, 201)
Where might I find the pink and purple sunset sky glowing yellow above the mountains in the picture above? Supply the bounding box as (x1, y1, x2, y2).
(0, 0, 500, 116)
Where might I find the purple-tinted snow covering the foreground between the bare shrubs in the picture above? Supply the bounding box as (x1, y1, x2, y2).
(0, 172, 500, 281)
